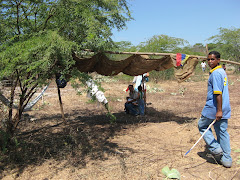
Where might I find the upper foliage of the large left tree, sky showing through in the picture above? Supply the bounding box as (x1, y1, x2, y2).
(0, 0, 131, 48)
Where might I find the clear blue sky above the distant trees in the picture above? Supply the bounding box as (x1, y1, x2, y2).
(112, 0, 240, 45)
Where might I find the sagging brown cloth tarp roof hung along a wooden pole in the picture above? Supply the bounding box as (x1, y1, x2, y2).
(73, 51, 240, 81)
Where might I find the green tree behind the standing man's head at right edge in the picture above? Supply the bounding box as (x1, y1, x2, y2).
(208, 28, 240, 62)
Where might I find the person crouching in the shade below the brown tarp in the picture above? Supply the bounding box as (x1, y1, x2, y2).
(125, 85, 138, 116)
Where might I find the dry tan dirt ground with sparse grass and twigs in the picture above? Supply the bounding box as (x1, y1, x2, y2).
(0, 72, 240, 180)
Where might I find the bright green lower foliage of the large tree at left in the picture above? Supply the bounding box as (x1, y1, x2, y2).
(0, 31, 77, 84)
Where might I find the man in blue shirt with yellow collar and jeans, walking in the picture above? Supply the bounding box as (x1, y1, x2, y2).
(198, 51, 232, 168)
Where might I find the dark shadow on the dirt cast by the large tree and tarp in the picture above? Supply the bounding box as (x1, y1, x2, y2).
(0, 108, 193, 174)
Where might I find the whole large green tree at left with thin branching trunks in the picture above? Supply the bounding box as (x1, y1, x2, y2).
(0, 0, 131, 135)
